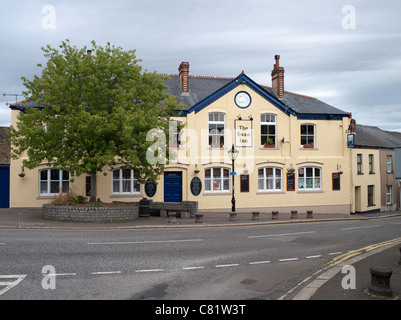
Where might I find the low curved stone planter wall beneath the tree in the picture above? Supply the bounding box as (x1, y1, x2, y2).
(42, 203, 139, 223)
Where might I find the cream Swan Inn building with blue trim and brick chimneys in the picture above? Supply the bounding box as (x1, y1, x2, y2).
(11, 56, 354, 214)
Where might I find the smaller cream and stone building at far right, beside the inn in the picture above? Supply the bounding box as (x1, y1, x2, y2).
(352, 124, 401, 212)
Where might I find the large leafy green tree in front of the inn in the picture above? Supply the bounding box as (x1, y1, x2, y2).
(10, 40, 181, 201)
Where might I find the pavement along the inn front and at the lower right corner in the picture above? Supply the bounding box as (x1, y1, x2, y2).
(0, 208, 401, 300)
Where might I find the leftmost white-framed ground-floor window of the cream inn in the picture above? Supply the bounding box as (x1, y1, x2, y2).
(39, 169, 70, 196)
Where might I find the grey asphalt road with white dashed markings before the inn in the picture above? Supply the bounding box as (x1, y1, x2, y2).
(0, 217, 401, 300)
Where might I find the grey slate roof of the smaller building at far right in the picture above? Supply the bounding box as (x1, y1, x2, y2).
(355, 124, 401, 149)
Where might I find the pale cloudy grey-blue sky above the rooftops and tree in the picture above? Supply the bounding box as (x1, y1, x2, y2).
(0, 0, 401, 131)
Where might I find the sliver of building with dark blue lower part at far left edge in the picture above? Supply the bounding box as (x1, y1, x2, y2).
(0, 127, 10, 208)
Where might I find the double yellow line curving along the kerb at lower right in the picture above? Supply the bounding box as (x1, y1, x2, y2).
(278, 238, 401, 300)
